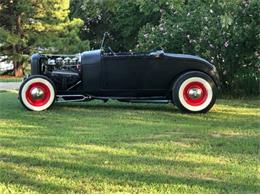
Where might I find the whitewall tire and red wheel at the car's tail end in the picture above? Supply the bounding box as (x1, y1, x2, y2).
(172, 71, 217, 113)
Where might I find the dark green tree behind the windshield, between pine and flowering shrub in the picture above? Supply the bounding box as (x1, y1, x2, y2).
(71, 0, 160, 51)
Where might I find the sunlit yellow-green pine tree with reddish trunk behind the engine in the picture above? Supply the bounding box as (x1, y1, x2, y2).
(0, 0, 89, 76)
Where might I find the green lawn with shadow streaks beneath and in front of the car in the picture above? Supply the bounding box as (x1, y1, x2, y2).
(0, 92, 260, 193)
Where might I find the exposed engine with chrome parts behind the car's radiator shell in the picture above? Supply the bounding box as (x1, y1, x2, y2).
(42, 55, 81, 91)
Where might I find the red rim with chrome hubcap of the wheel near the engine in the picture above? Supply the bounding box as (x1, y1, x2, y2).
(25, 82, 51, 107)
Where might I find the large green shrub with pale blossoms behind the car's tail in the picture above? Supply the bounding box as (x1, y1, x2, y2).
(137, 0, 260, 95)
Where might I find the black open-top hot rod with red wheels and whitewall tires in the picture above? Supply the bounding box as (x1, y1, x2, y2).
(19, 36, 219, 112)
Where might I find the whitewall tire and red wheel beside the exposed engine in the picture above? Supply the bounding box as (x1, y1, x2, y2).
(19, 75, 56, 111)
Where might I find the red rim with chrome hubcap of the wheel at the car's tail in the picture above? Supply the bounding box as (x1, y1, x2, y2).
(183, 82, 208, 106)
